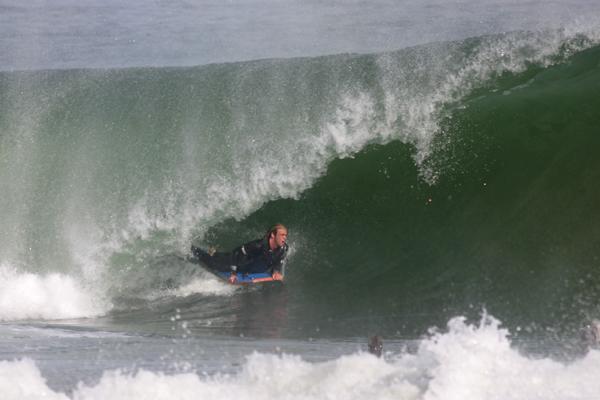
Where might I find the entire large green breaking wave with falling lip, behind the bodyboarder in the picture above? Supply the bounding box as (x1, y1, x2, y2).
(0, 32, 600, 342)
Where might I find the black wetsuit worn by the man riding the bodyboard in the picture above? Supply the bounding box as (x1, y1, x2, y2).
(192, 238, 288, 275)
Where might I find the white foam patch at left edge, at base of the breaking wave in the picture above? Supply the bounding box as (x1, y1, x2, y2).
(0, 265, 105, 321)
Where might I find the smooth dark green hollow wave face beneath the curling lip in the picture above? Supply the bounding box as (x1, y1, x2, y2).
(209, 43, 600, 334)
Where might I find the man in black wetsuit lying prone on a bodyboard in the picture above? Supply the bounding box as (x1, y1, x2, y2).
(191, 224, 288, 283)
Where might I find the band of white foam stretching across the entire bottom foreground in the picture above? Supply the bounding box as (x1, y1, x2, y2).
(0, 317, 600, 400)
